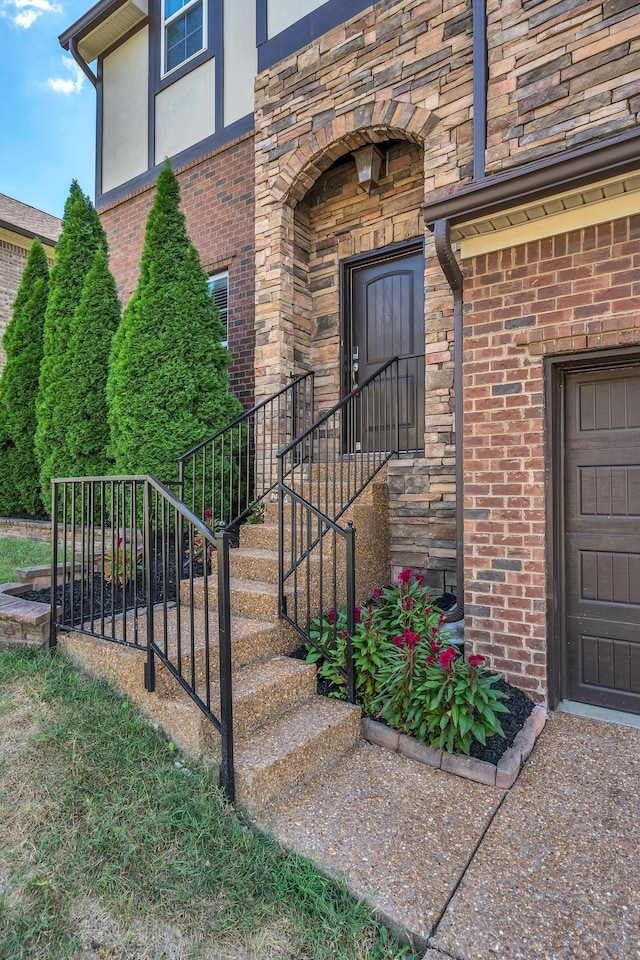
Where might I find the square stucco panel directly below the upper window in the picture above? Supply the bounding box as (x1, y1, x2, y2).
(155, 58, 215, 163)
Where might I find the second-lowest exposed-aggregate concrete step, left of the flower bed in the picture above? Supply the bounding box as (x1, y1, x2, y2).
(201, 657, 317, 750)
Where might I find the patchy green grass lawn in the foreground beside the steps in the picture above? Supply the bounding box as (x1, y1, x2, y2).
(0, 651, 416, 960)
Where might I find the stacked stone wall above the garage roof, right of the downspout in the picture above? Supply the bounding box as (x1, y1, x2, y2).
(487, 0, 640, 172)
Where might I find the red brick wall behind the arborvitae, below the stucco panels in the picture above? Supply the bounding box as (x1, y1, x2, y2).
(100, 135, 255, 409)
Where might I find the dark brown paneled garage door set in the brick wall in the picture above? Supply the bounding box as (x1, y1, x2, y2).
(564, 366, 640, 713)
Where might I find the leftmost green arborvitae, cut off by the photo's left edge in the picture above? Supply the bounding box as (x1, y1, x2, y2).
(0, 240, 50, 516)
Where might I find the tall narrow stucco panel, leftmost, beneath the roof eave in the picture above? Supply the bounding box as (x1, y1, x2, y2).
(102, 27, 149, 193)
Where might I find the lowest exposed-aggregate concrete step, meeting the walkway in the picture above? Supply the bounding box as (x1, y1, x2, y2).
(235, 697, 360, 812)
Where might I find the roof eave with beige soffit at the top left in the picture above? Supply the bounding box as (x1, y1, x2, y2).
(58, 0, 149, 64)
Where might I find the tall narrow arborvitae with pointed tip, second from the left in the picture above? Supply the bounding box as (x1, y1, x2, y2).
(36, 180, 107, 503)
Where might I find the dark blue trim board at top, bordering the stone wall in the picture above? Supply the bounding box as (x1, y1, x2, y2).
(256, 0, 373, 73)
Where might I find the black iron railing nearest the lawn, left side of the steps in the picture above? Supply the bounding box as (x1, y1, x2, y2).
(50, 476, 234, 800)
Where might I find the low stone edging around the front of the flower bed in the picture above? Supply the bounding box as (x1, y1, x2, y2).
(362, 704, 547, 790)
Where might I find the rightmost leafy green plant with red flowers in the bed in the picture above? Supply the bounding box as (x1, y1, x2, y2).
(407, 647, 507, 754)
